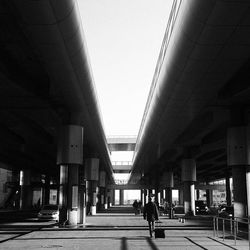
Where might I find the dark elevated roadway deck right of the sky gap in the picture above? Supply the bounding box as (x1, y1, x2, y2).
(130, 0, 250, 218)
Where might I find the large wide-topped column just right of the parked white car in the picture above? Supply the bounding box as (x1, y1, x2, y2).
(57, 125, 83, 225)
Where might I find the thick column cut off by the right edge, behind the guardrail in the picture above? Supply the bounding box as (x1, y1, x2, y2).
(227, 126, 250, 217)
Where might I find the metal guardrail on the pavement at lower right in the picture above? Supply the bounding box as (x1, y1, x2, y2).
(213, 216, 250, 249)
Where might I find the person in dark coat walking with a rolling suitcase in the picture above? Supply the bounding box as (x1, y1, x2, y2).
(143, 197, 159, 238)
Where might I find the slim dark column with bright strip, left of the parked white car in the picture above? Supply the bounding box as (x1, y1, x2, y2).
(20, 169, 33, 209)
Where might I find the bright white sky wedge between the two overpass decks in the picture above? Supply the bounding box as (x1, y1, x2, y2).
(78, 0, 172, 135)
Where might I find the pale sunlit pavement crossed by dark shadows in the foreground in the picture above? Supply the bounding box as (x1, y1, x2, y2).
(0, 213, 249, 250)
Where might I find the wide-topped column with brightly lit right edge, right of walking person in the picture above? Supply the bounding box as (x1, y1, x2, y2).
(181, 159, 196, 215)
